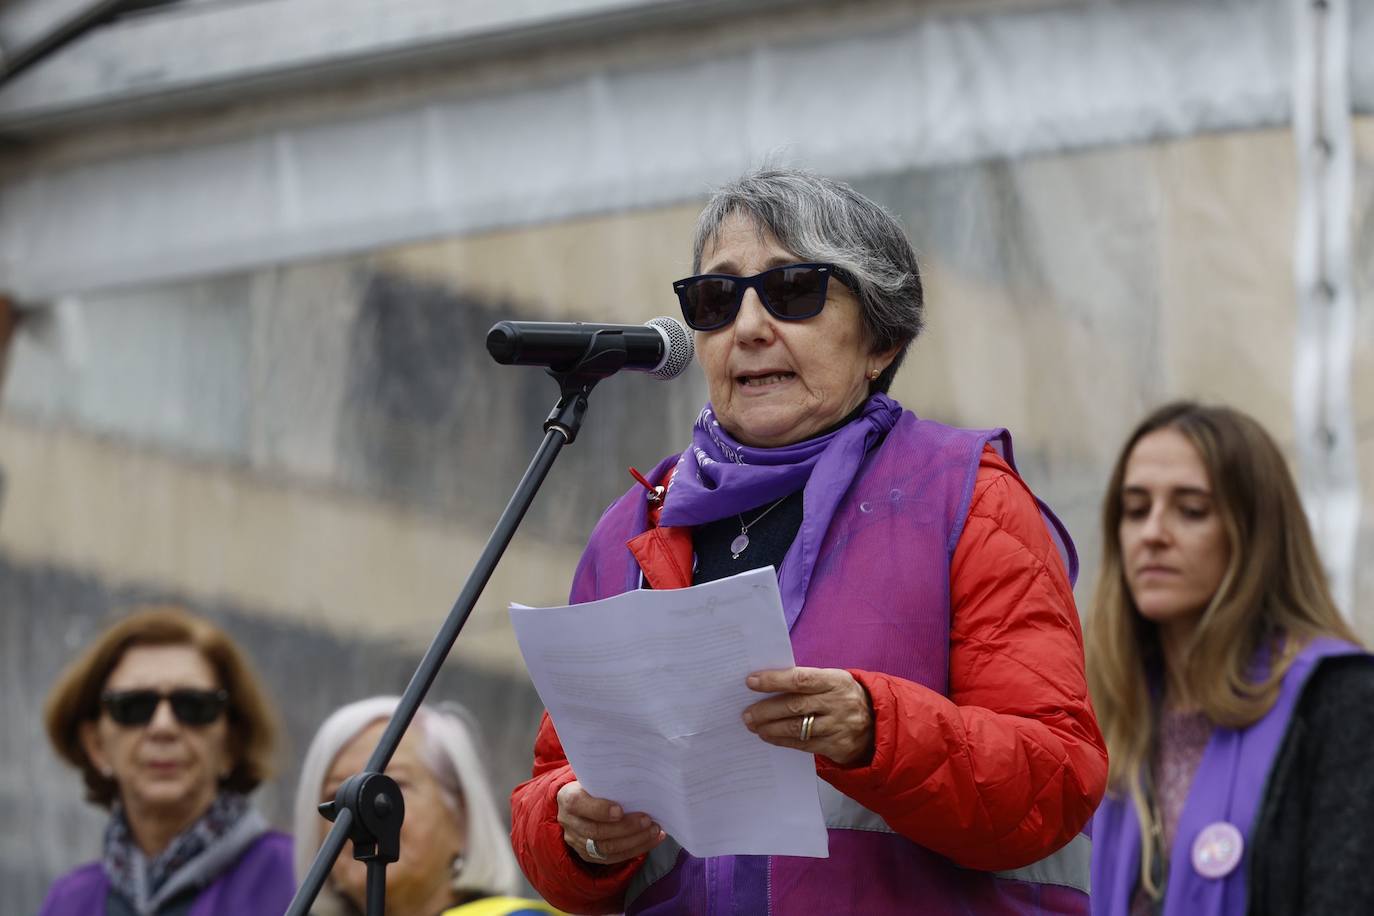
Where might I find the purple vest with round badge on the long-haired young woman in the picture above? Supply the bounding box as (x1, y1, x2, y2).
(1092, 637, 1362, 916)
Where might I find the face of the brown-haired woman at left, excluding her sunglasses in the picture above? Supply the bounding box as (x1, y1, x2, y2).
(81, 645, 234, 823)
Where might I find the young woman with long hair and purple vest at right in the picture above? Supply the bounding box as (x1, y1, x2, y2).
(1087, 402, 1374, 916)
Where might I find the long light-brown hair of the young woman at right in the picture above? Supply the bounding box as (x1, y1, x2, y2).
(1084, 401, 1359, 894)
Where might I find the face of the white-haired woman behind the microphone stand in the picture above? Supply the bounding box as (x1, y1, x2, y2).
(320, 721, 467, 913)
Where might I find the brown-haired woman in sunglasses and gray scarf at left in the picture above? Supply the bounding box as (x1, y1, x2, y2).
(40, 607, 295, 916)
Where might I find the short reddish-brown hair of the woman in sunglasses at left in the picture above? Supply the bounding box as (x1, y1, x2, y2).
(44, 606, 278, 808)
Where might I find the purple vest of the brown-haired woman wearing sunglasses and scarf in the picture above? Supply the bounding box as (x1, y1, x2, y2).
(38, 831, 295, 916)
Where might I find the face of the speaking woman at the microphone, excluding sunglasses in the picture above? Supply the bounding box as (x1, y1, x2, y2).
(697, 213, 896, 448)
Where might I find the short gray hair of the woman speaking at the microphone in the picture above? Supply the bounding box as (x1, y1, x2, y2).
(692, 168, 925, 393)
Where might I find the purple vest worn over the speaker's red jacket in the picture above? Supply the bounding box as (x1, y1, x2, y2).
(572, 412, 1088, 916)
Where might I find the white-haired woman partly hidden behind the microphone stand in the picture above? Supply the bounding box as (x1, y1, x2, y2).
(295, 696, 558, 916)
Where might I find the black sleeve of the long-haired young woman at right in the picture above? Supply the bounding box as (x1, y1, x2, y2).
(1248, 656, 1374, 916)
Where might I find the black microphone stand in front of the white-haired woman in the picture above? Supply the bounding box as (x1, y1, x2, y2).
(286, 332, 628, 916)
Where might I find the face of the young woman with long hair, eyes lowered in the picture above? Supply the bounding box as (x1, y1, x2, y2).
(1120, 428, 1231, 629)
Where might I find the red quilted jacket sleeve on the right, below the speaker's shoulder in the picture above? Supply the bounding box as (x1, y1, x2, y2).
(816, 450, 1107, 871)
